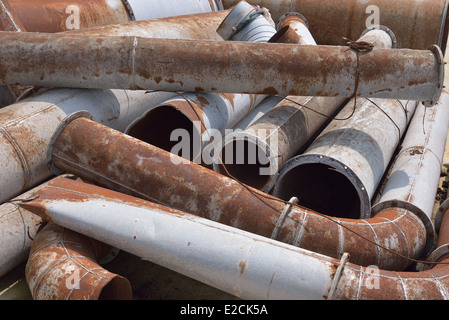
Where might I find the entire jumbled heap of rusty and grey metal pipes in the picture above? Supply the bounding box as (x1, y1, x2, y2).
(0, 0, 449, 300)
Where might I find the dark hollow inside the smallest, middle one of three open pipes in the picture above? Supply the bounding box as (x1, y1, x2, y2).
(219, 139, 270, 189)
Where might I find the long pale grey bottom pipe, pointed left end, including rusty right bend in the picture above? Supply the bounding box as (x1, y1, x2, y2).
(20, 179, 449, 300)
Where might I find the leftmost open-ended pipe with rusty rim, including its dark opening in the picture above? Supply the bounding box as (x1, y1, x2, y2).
(125, 93, 265, 166)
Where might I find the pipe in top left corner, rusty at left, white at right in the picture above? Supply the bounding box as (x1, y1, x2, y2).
(0, 0, 222, 33)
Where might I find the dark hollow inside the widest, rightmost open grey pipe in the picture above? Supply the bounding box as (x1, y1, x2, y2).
(276, 163, 361, 219)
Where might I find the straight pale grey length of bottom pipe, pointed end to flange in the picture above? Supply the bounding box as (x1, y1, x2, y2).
(20, 179, 335, 299)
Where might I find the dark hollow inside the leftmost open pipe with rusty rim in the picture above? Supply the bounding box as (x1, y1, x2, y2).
(127, 106, 195, 161)
